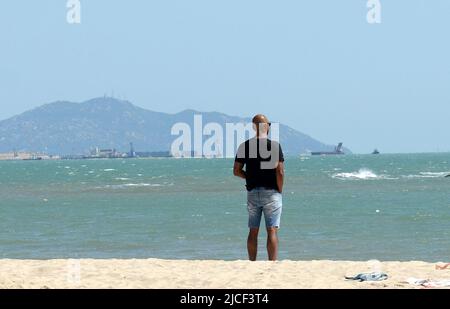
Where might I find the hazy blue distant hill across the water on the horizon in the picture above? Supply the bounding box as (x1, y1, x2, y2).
(0, 97, 350, 155)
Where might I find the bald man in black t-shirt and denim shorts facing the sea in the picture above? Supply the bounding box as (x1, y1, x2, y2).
(233, 114, 284, 261)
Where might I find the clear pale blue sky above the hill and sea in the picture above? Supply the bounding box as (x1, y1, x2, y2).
(0, 0, 450, 153)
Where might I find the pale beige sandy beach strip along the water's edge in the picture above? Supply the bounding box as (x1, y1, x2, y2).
(0, 259, 450, 289)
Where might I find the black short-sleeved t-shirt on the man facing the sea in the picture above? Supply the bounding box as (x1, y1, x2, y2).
(235, 138, 284, 191)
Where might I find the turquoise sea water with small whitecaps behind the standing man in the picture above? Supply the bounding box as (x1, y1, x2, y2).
(0, 154, 450, 261)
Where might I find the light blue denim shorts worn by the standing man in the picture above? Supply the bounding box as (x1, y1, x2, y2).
(247, 188, 283, 228)
